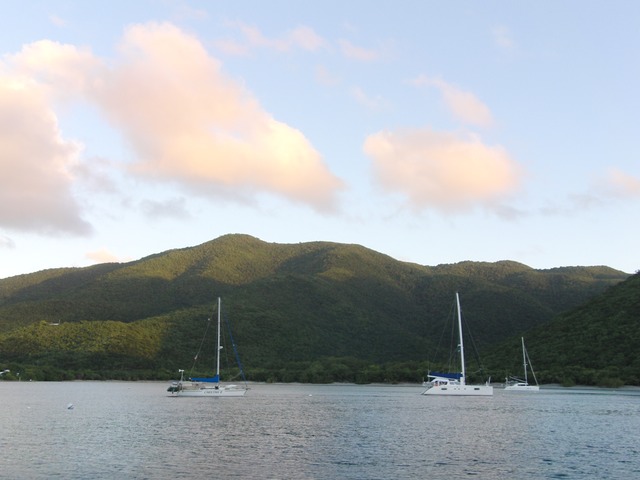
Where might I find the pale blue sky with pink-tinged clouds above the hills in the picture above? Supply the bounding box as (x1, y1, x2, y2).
(0, 0, 640, 278)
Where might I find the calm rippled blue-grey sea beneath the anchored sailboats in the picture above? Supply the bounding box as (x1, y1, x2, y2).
(0, 382, 640, 480)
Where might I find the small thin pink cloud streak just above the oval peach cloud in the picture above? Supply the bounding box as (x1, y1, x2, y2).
(411, 75, 494, 127)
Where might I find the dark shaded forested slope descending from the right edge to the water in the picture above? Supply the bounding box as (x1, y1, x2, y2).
(486, 274, 640, 386)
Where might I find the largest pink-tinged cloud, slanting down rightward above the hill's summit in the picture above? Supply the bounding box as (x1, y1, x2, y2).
(94, 24, 342, 210)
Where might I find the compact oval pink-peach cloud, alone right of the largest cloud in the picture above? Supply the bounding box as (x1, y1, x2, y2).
(364, 128, 521, 212)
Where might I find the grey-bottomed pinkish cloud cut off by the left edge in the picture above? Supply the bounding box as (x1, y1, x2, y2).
(0, 76, 91, 234)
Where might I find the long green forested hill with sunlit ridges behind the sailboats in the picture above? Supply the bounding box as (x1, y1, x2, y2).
(0, 235, 628, 381)
